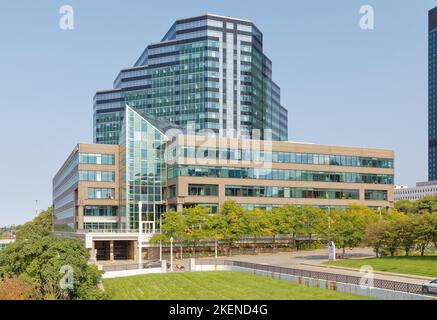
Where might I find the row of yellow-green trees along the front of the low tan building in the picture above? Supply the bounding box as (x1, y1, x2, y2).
(151, 201, 418, 252)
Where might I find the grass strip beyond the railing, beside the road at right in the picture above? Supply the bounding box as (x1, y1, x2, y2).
(326, 256, 437, 278)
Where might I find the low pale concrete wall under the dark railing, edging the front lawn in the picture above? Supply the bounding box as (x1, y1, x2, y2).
(192, 265, 435, 300)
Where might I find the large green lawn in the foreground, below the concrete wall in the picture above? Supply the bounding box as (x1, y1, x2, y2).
(103, 271, 367, 300)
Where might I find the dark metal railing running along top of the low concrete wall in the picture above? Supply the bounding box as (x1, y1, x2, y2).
(196, 259, 423, 294)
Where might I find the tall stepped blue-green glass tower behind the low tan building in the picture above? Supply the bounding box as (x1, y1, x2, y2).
(94, 14, 288, 144)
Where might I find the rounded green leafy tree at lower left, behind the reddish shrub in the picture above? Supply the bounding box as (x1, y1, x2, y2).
(0, 236, 103, 299)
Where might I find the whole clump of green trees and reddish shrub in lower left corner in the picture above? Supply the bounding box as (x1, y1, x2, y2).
(0, 208, 104, 300)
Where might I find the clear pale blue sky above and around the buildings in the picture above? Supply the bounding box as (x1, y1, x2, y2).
(0, 0, 437, 225)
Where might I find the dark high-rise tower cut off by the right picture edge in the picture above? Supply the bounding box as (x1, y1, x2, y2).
(428, 7, 437, 181)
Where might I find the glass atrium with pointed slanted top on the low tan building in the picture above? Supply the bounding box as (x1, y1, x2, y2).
(119, 107, 168, 229)
